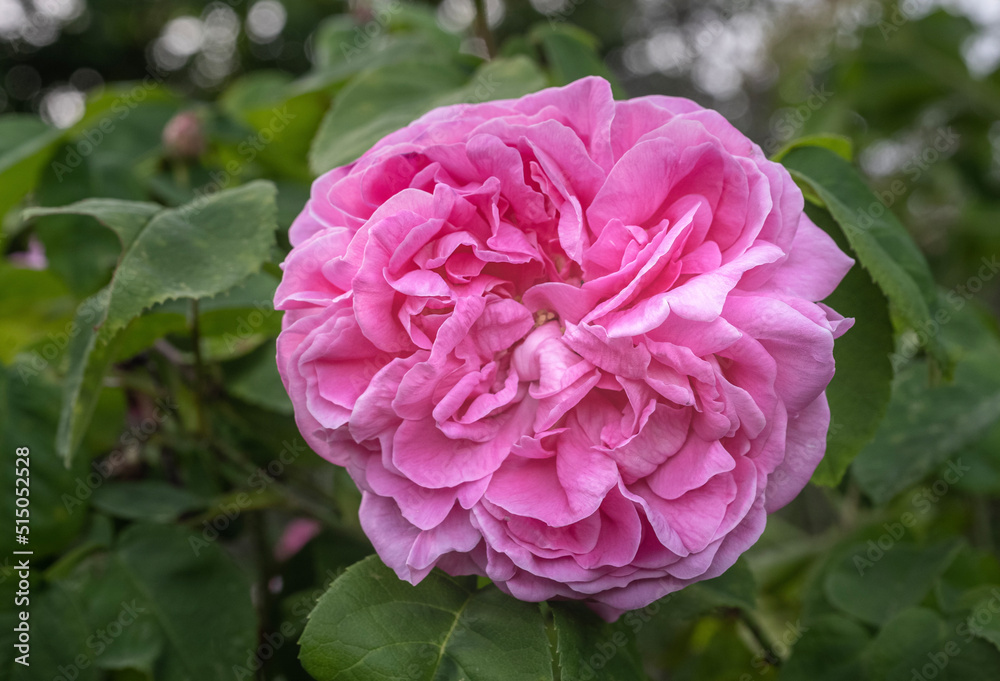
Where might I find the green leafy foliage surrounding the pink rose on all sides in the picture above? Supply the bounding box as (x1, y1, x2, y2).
(0, 4, 1000, 681)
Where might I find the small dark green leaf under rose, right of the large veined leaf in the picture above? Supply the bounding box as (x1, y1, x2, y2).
(551, 603, 647, 681)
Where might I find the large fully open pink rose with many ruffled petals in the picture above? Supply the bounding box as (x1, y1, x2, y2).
(275, 78, 852, 618)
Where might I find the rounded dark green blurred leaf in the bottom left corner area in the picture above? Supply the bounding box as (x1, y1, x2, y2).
(75, 524, 257, 681)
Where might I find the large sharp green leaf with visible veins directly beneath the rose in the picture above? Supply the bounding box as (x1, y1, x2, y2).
(299, 556, 552, 681)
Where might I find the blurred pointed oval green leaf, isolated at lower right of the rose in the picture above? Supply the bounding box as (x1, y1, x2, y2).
(823, 541, 961, 624)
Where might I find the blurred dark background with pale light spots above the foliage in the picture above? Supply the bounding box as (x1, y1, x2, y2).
(0, 0, 1000, 288)
